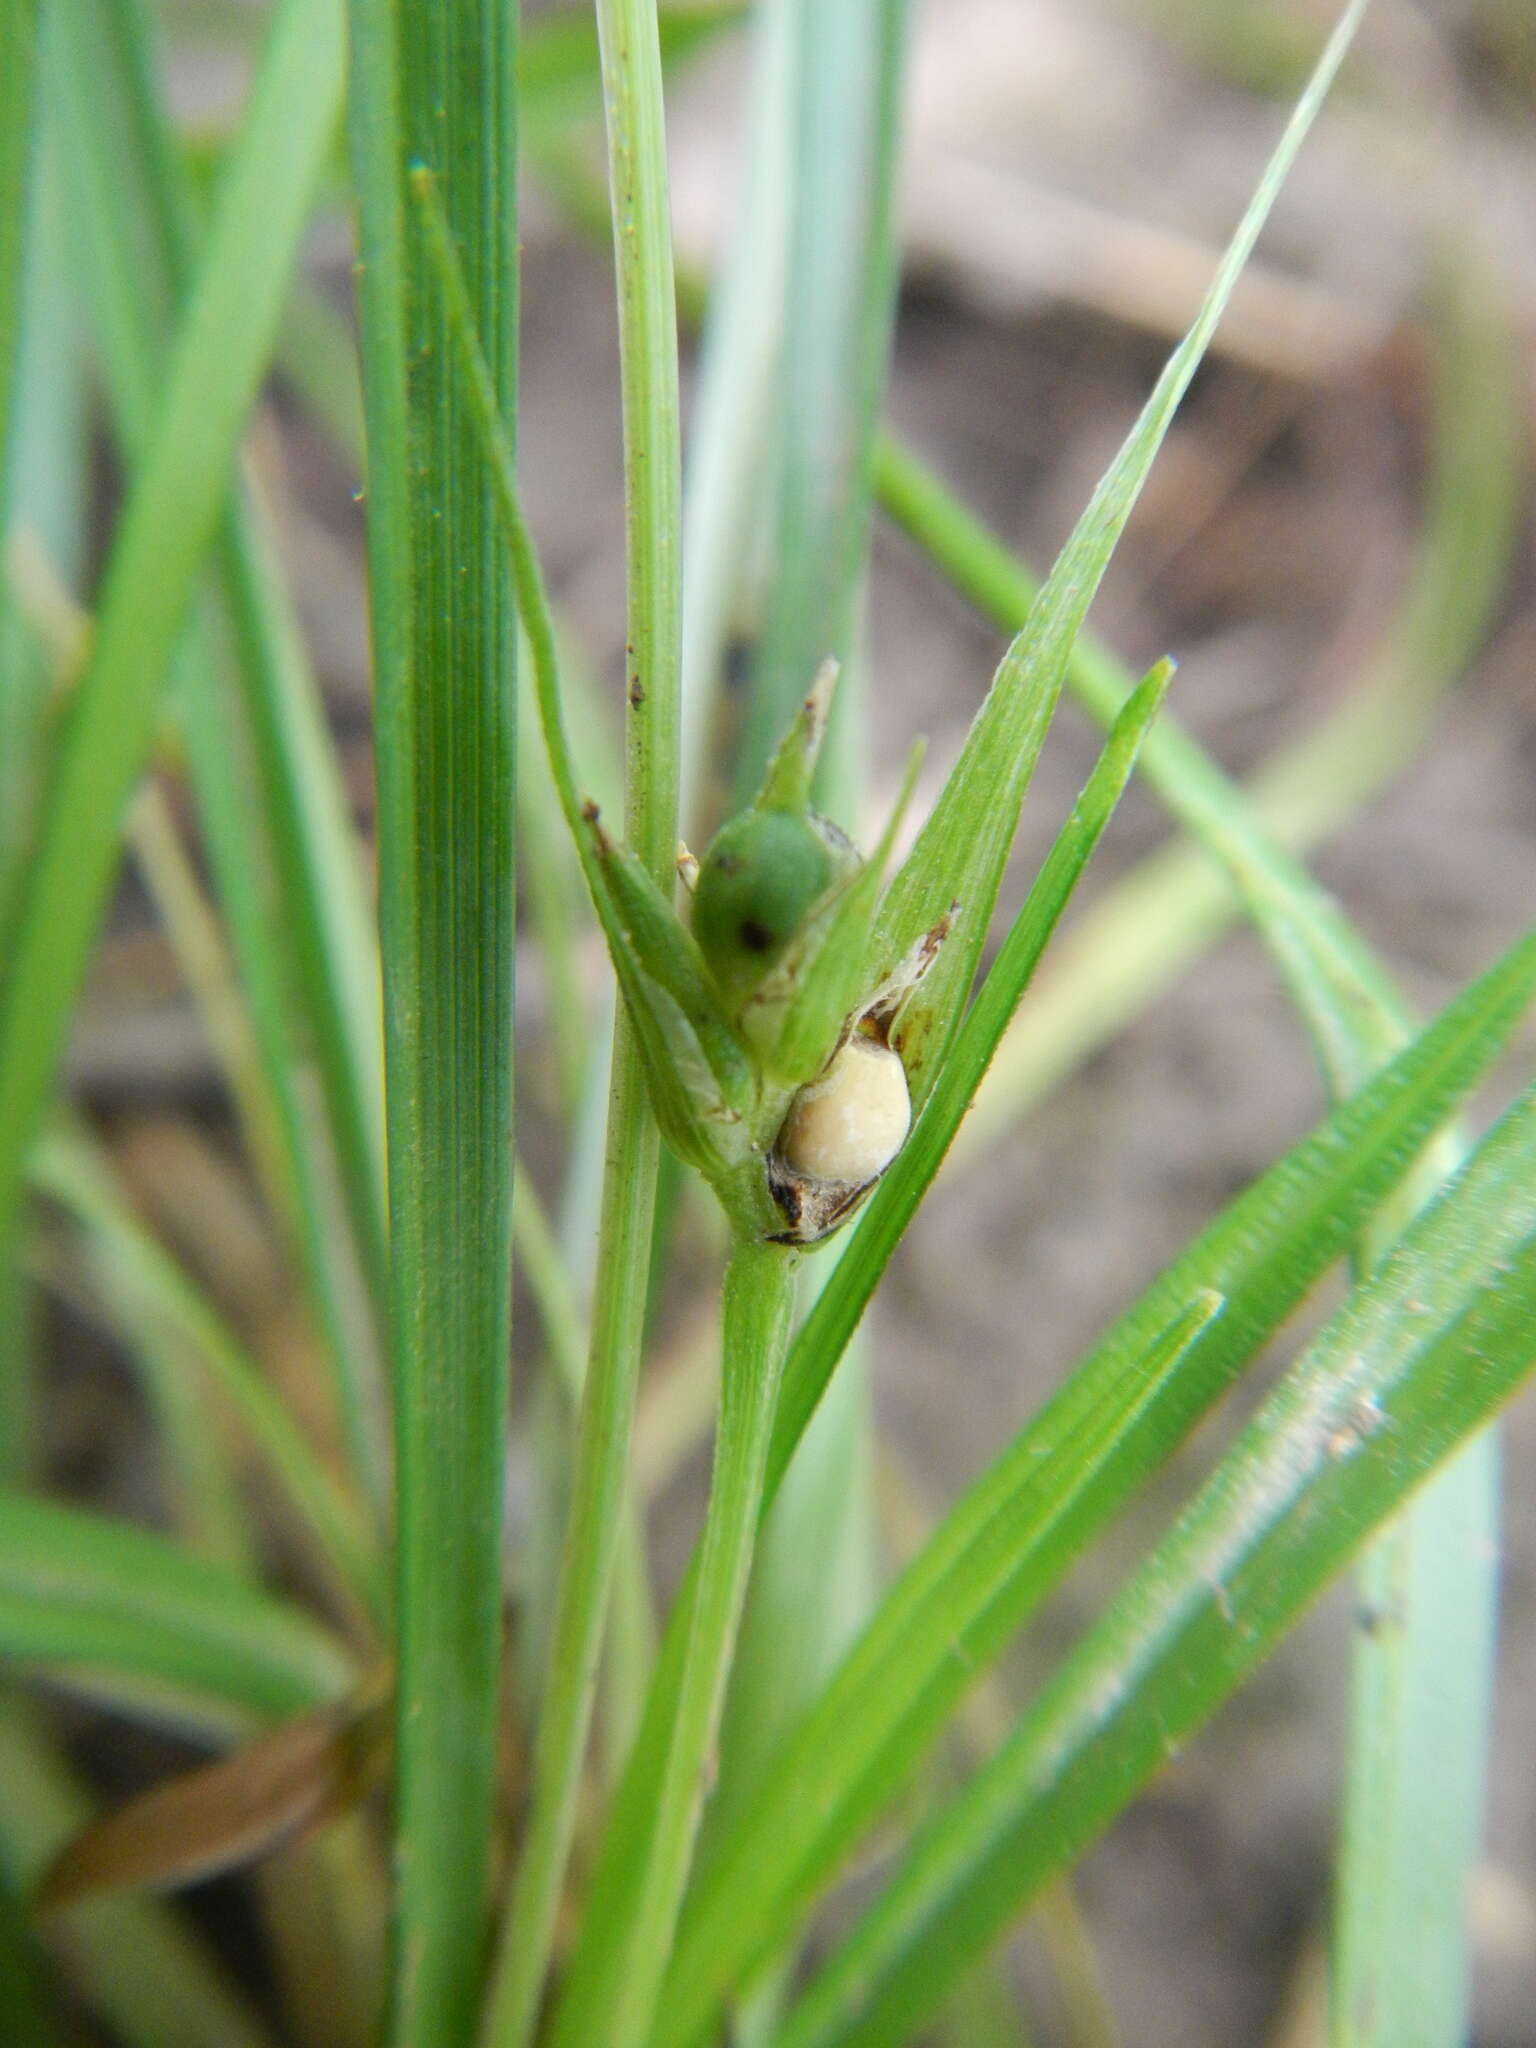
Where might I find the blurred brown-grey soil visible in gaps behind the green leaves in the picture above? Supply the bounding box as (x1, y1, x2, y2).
(49, 0, 1536, 2048)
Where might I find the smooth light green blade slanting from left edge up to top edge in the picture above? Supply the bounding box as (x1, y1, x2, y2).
(0, 0, 342, 1343)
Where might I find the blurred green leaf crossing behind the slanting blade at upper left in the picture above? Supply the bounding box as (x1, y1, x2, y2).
(57, 0, 387, 1511)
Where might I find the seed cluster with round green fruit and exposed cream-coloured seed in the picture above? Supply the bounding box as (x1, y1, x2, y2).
(586, 662, 942, 1245)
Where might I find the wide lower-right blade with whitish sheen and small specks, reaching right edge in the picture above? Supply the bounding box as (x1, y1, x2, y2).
(776, 1096, 1536, 2048)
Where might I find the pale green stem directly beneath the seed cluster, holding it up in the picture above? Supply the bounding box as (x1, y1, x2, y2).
(604, 1241, 797, 2048)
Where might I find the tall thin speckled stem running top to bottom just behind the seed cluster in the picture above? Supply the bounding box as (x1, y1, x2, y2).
(471, 0, 682, 2048)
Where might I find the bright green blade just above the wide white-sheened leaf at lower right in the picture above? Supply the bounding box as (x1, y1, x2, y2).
(670, 940, 1536, 2038)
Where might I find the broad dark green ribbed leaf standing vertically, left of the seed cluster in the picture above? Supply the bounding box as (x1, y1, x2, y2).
(350, 0, 518, 2048)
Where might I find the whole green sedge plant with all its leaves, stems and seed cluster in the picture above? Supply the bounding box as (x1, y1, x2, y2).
(0, 0, 1536, 2048)
